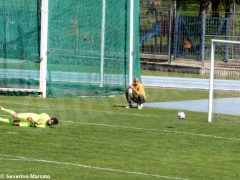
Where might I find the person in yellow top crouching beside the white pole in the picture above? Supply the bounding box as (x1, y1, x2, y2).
(126, 77, 146, 109)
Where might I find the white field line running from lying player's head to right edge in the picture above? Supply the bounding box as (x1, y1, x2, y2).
(62, 121, 240, 141)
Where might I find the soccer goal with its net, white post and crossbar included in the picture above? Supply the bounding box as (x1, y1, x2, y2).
(208, 39, 240, 122)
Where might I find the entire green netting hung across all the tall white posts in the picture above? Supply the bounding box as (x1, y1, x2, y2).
(0, 0, 140, 97)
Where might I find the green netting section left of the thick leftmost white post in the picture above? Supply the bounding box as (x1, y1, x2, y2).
(0, 0, 40, 93)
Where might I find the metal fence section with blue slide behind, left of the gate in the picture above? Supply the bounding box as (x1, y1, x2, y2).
(139, 1, 170, 55)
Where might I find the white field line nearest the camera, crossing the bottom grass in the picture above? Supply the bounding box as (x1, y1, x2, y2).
(0, 154, 188, 180)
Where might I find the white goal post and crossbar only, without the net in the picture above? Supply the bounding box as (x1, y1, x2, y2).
(208, 39, 240, 122)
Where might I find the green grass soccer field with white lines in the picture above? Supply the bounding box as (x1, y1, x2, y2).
(0, 88, 240, 180)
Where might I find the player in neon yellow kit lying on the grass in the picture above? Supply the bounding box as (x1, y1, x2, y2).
(0, 106, 58, 128)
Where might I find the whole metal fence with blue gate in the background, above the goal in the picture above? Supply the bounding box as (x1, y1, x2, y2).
(139, 1, 240, 61)
